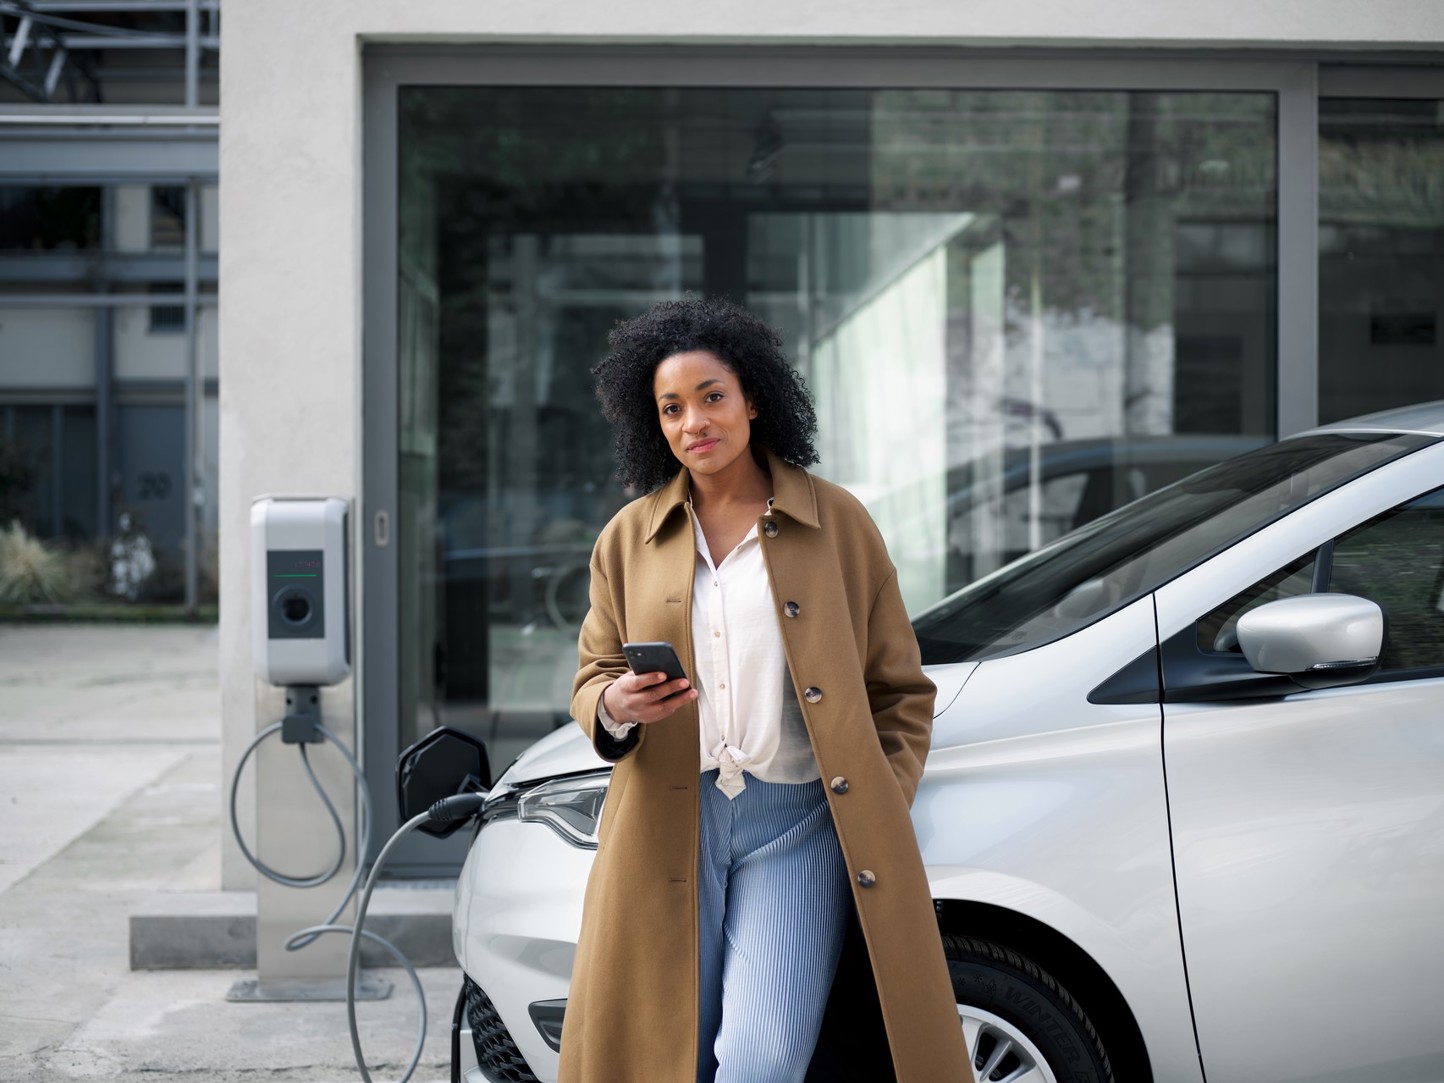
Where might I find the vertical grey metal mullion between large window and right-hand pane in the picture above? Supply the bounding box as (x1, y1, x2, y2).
(1275, 62, 1318, 438)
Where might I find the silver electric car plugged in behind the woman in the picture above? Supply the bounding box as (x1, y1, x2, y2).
(438, 403, 1444, 1083)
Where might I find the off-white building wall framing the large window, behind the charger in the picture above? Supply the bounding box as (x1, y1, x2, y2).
(219, 0, 1444, 887)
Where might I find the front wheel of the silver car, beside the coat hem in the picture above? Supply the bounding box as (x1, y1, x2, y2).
(943, 936, 1113, 1083)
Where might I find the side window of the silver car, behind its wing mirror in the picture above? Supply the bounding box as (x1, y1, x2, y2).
(1199, 488, 1444, 673)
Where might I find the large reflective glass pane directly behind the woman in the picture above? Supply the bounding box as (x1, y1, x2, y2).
(397, 87, 1276, 762)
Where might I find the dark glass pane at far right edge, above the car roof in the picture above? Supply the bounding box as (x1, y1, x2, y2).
(1318, 98, 1444, 422)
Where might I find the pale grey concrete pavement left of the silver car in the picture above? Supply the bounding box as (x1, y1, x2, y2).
(0, 624, 461, 1083)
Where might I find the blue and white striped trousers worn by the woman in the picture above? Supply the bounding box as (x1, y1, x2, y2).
(697, 771, 852, 1083)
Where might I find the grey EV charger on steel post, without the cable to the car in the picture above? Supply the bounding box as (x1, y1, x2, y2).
(228, 495, 391, 1001)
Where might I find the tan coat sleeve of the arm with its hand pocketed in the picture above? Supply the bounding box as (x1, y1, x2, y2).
(864, 570, 937, 806)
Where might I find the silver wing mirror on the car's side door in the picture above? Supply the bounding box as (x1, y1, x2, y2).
(1238, 593, 1385, 689)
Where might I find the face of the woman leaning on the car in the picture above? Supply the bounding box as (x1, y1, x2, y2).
(651, 349, 757, 478)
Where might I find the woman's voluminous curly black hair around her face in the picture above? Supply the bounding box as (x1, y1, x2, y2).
(592, 297, 817, 491)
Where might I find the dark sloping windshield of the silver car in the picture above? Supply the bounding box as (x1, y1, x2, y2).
(913, 433, 1437, 666)
